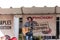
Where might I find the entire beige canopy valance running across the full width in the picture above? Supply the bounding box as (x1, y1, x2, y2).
(0, 7, 60, 14)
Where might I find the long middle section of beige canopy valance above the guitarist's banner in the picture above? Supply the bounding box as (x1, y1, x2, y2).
(23, 7, 55, 14)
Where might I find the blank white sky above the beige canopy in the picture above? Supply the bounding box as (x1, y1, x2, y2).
(0, 0, 60, 8)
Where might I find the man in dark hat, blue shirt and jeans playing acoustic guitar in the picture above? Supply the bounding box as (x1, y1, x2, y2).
(24, 17, 38, 40)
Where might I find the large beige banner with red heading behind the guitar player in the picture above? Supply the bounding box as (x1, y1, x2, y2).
(23, 15, 56, 36)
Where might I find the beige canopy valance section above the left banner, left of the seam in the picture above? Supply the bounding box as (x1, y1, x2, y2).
(0, 8, 22, 14)
